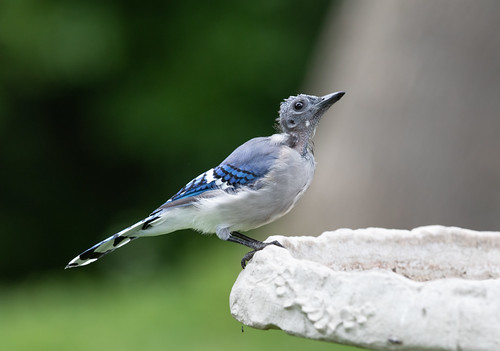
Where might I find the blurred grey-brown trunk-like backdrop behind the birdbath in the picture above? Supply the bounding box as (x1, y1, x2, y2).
(273, 0, 500, 235)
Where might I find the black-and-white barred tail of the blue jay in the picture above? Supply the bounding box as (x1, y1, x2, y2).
(66, 221, 143, 268)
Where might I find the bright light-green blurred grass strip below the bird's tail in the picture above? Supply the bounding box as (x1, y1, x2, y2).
(0, 247, 366, 351)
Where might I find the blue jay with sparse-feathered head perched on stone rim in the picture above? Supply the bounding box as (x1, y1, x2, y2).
(66, 91, 345, 269)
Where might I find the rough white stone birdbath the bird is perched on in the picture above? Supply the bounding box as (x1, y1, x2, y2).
(230, 226, 500, 350)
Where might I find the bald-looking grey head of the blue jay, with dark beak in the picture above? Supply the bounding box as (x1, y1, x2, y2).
(278, 91, 345, 135)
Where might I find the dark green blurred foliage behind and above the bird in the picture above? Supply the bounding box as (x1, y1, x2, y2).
(0, 0, 338, 280)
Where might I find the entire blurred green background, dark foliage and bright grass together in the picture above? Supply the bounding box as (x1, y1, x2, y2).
(0, 0, 360, 350)
